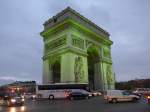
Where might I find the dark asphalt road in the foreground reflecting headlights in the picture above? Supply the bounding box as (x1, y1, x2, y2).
(0, 97, 150, 112)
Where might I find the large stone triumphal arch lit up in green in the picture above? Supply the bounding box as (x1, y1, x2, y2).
(41, 7, 115, 90)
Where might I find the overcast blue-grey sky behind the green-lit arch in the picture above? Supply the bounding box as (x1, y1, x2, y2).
(0, 0, 150, 83)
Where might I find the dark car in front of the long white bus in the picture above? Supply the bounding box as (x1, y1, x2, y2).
(67, 90, 92, 100)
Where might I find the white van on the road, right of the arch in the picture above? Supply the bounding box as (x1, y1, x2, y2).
(104, 90, 140, 103)
